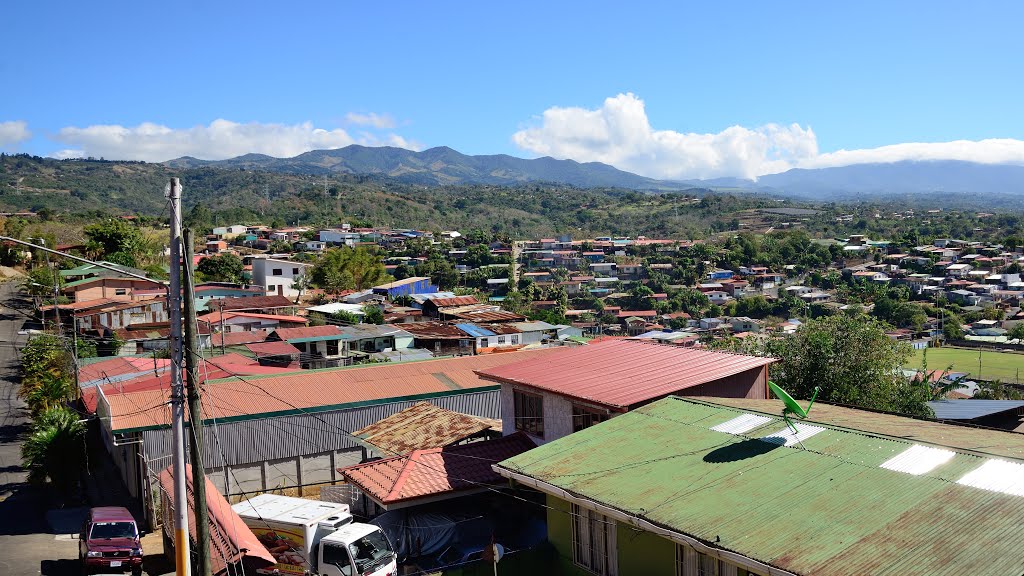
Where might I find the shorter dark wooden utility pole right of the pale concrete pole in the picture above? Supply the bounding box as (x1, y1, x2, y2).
(181, 229, 211, 576)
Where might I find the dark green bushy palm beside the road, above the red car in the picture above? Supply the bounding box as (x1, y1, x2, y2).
(22, 407, 85, 494)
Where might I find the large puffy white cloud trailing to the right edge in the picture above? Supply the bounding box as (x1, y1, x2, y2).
(512, 93, 1024, 179)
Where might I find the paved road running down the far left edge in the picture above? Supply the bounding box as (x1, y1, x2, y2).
(0, 282, 81, 576)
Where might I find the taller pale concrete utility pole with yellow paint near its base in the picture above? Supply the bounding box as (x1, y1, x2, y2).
(166, 178, 191, 576)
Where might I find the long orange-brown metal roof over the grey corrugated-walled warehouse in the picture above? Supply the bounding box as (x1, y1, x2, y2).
(108, 342, 556, 434)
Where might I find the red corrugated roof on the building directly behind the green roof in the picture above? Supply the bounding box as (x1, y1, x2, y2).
(477, 340, 775, 408)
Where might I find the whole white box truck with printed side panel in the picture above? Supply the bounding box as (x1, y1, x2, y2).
(231, 494, 398, 576)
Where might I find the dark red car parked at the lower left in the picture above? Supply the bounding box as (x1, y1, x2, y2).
(78, 506, 142, 576)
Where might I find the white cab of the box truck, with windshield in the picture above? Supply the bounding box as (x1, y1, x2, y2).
(317, 524, 398, 576)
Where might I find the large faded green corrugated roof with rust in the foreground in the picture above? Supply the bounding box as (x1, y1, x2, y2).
(500, 398, 1024, 576)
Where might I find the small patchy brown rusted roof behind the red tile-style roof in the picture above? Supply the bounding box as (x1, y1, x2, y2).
(352, 402, 501, 455)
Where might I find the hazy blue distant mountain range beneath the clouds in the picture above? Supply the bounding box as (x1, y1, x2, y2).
(164, 145, 1024, 200)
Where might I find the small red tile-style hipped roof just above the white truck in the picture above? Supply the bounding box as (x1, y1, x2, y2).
(338, 433, 535, 509)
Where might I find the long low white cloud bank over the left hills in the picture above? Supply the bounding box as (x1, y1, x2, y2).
(54, 119, 416, 162)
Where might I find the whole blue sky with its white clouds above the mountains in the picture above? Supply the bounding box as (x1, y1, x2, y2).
(0, 1, 1024, 177)
